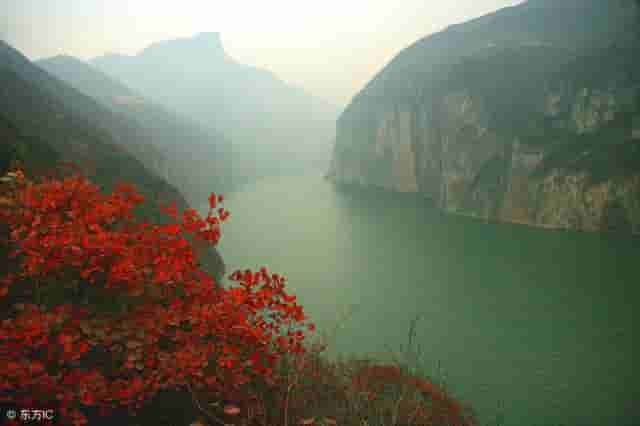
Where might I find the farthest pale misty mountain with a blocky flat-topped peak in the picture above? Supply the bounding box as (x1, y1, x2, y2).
(90, 33, 338, 176)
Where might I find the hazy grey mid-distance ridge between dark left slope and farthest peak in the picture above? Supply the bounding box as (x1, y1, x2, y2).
(36, 56, 232, 203)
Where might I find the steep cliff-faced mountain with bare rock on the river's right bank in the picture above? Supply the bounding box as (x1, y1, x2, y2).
(328, 0, 640, 233)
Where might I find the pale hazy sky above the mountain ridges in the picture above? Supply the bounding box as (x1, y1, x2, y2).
(0, 0, 524, 106)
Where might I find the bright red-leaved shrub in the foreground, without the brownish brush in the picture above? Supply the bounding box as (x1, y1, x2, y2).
(0, 174, 306, 424)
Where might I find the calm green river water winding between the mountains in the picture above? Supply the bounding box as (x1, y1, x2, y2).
(214, 176, 640, 426)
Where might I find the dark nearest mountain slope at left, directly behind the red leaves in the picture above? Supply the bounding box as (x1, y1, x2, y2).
(0, 40, 224, 276)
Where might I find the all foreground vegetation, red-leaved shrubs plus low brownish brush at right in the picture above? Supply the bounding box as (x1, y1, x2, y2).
(0, 170, 474, 426)
